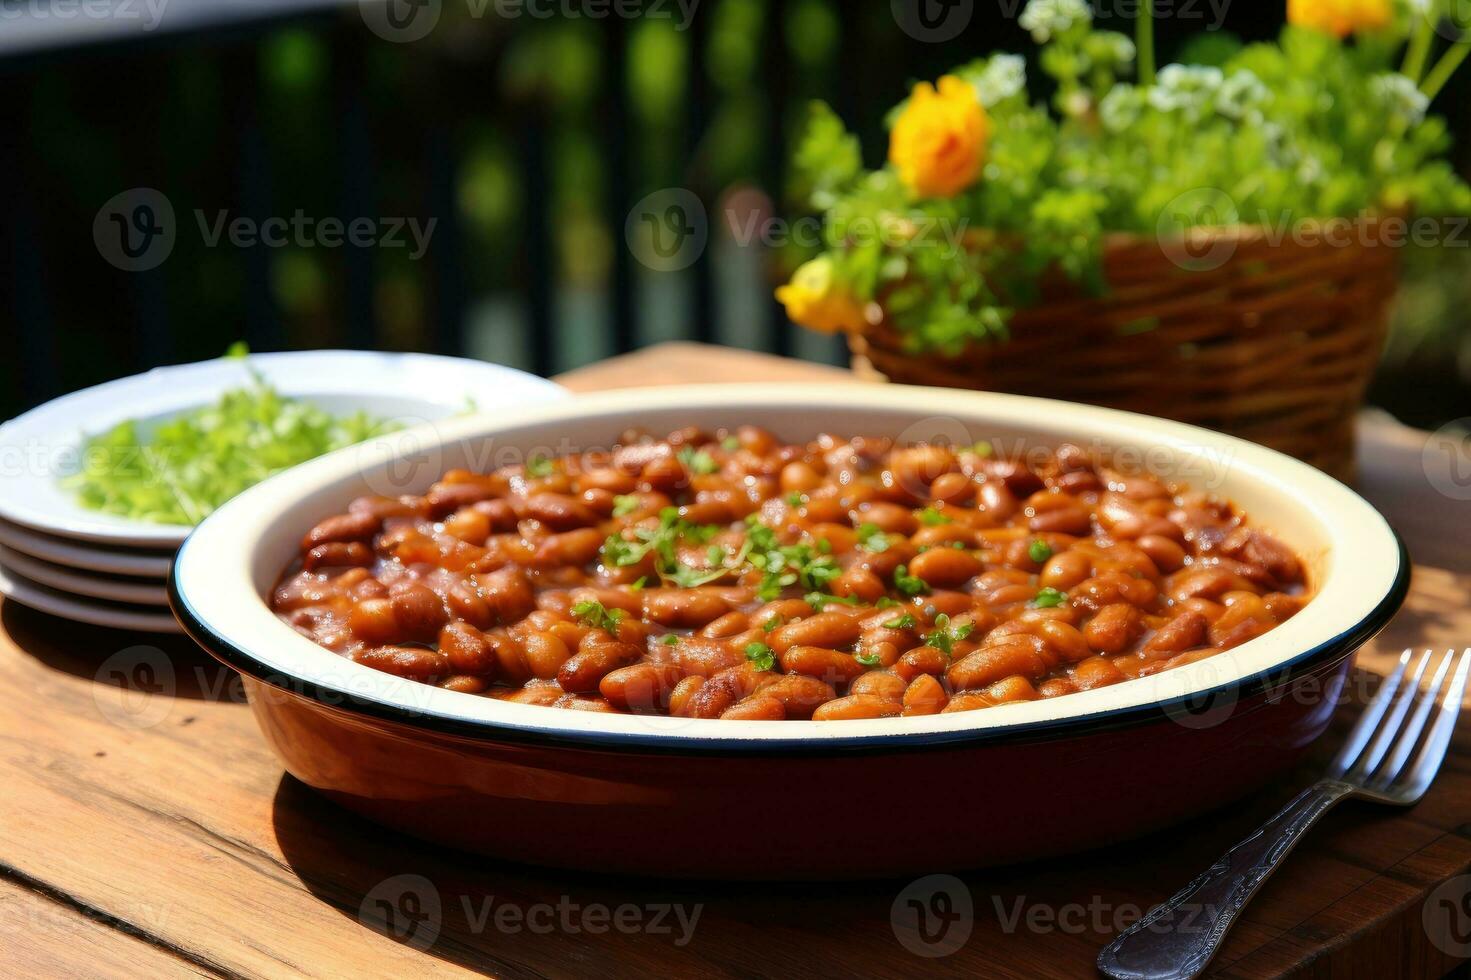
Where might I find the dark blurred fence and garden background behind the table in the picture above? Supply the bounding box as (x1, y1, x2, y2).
(0, 0, 1471, 428)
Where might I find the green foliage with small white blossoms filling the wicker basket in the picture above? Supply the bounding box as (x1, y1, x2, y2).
(796, 0, 1471, 355)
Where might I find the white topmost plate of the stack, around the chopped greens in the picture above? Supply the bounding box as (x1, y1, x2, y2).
(0, 350, 568, 550)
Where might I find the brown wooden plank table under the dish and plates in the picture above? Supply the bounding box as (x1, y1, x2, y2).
(0, 344, 1471, 977)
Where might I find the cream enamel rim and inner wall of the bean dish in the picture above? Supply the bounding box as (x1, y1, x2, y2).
(171, 384, 1408, 750)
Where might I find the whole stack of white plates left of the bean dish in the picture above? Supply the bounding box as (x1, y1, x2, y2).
(0, 350, 566, 633)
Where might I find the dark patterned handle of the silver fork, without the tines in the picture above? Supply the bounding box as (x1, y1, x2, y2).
(1097, 780, 1353, 980)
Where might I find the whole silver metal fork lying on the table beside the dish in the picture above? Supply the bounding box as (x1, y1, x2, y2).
(1099, 649, 1471, 980)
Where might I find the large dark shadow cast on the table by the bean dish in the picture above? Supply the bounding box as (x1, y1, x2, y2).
(261, 670, 1389, 977)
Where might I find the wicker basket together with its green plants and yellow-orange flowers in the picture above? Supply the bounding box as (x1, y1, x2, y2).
(777, 0, 1471, 475)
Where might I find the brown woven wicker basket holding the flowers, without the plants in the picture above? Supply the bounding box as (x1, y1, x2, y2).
(849, 222, 1397, 480)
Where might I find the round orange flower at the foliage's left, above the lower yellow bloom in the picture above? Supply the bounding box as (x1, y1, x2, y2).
(888, 75, 991, 197)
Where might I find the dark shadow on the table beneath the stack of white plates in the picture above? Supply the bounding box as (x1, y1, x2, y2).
(0, 600, 246, 703)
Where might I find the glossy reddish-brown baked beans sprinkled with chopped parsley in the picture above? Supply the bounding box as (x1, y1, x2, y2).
(271, 427, 1308, 721)
